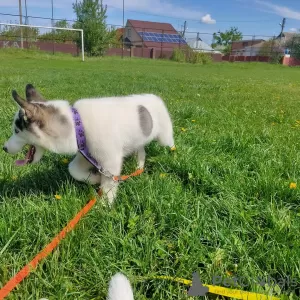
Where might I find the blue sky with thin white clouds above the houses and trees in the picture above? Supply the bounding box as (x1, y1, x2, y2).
(0, 0, 300, 43)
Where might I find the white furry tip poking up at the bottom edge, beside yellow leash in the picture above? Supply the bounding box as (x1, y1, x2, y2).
(107, 273, 134, 300)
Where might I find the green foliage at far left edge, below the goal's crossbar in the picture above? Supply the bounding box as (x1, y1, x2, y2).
(0, 25, 39, 42)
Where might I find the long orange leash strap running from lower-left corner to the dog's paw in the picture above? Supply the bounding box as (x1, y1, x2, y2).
(0, 198, 96, 300)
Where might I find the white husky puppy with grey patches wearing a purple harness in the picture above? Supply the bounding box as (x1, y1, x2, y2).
(3, 84, 174, 203)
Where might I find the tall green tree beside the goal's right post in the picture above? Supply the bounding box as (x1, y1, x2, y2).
(73, 0, 115, 56)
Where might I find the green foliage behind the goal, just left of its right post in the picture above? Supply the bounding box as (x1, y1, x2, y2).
(39, 20, 79, 43)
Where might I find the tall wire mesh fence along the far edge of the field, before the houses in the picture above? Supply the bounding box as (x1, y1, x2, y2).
(0, 13, 300, 62)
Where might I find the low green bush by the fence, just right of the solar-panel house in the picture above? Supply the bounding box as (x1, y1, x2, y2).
(171, 48, 212, 65)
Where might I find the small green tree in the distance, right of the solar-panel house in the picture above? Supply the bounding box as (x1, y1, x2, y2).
(211, 27, 243, 54)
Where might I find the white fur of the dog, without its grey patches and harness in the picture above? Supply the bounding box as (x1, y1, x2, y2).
(5, 94, 174, 203)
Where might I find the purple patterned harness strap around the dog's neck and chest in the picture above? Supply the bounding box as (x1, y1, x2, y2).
(72, 107, 104, 174)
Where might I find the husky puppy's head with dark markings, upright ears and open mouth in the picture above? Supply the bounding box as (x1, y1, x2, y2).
(3, 84, 61, 165)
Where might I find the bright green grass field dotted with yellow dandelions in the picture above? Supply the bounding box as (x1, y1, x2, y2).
(0, 51, 300, 299)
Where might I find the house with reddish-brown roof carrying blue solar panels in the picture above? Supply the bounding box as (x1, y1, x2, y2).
(124, 20, 187, 51)
